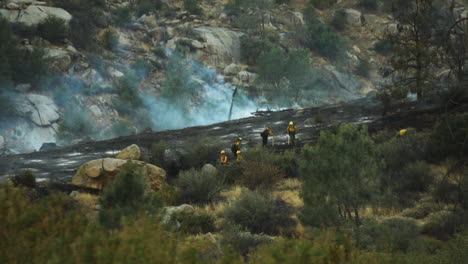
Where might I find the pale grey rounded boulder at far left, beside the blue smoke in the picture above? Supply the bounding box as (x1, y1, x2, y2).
(16, 93, 60, 126)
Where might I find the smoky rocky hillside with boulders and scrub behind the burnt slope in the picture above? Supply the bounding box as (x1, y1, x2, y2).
(0, 0, 467, 154)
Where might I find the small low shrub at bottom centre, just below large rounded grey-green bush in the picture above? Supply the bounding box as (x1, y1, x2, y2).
(221, 225, 273, 256)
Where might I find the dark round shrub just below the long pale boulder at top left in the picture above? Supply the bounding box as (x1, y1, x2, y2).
(37, 16, 68, 43)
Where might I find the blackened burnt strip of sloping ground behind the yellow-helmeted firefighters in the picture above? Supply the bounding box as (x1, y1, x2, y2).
(0, 98, 454, 181)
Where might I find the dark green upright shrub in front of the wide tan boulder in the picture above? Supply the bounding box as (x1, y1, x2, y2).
(98, 161, 156, 229)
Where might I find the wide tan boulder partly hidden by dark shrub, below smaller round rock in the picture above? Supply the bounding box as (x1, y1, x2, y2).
(72, 158, 166, 191)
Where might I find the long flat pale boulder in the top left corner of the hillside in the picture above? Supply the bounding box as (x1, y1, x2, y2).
(0, 5, 72, 26)
